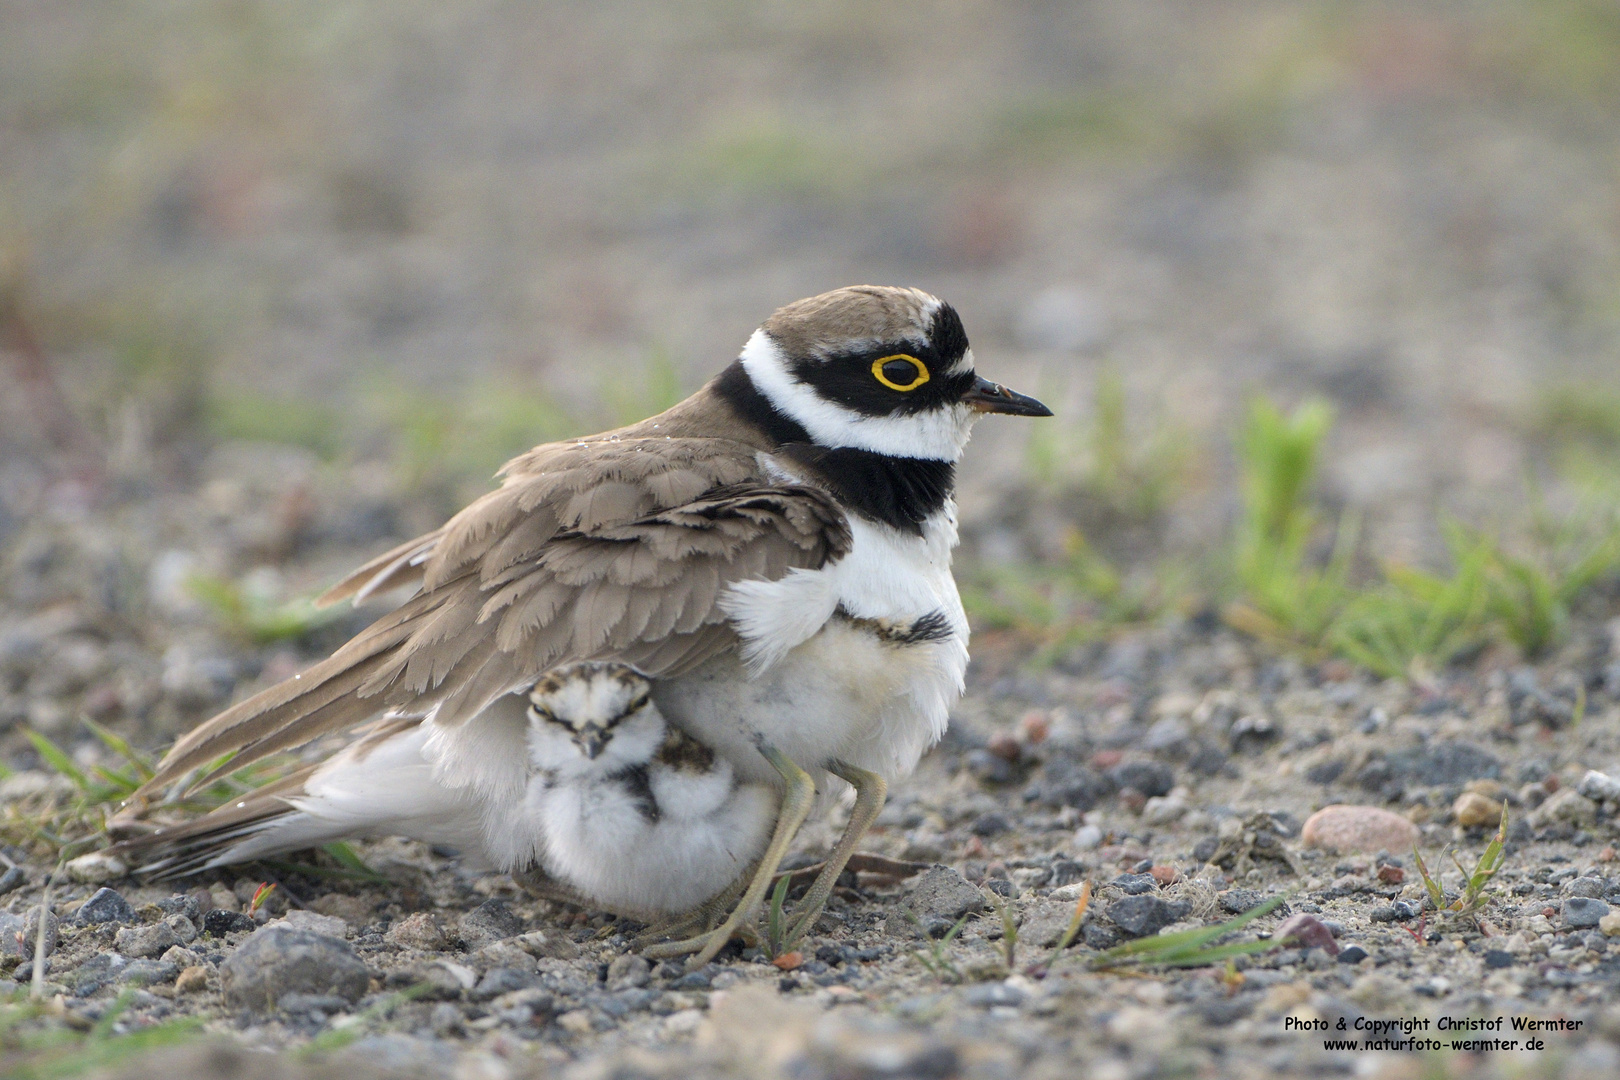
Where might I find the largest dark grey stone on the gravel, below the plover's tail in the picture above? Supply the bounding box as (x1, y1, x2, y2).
(219, 928, 371, 1012)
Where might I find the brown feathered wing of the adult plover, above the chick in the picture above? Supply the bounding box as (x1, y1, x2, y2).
(126, 433, 851, 814)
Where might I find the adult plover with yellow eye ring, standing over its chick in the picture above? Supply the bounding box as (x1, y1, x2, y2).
(120, 285, 1051, 962)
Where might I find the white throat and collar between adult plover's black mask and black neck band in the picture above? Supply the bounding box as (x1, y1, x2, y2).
(740, 330, 978, 461)
